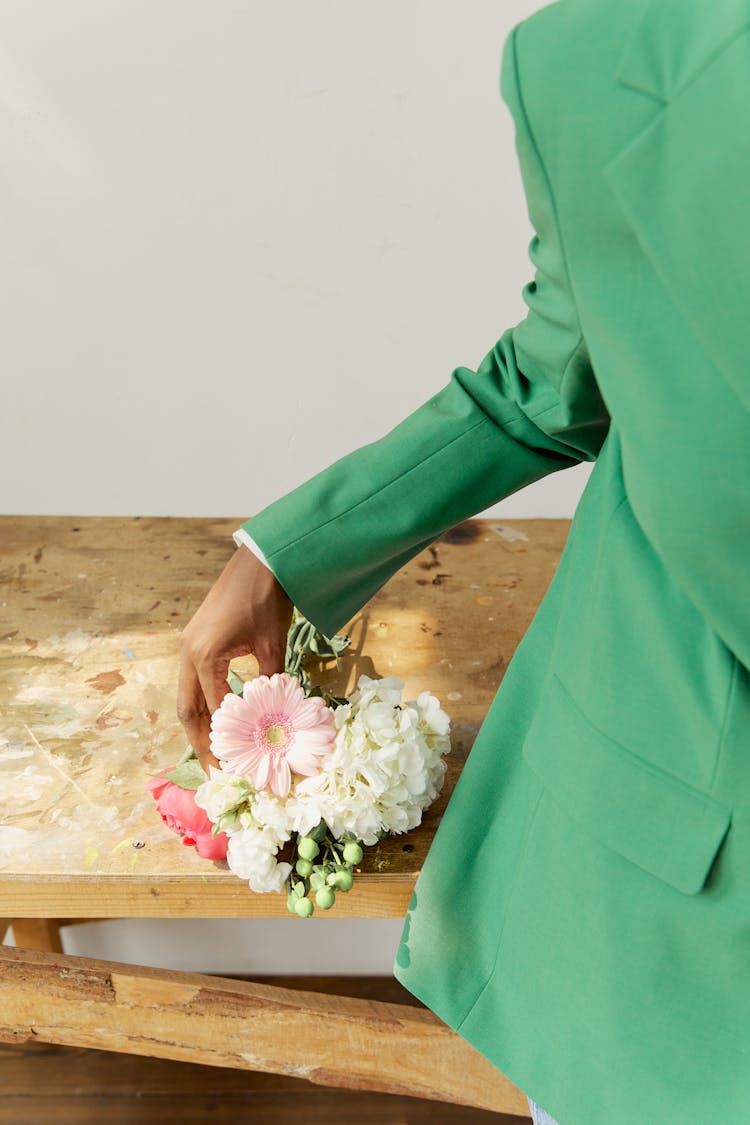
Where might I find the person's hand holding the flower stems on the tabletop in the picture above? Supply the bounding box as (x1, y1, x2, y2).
(177, 546, 293, 774)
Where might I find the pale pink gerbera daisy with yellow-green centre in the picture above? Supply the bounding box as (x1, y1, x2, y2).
(210, 672, 336, 797)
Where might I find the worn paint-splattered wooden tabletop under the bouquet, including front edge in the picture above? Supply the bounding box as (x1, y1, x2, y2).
(0, 516, 570, 917)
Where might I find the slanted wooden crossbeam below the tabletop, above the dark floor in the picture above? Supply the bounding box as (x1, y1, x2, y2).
(0, 946, 527, 1115)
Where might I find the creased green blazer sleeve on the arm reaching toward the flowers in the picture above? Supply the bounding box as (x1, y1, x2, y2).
(242, 25, 609, 636)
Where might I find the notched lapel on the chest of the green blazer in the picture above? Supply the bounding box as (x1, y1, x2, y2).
(604, 0, 750, 411)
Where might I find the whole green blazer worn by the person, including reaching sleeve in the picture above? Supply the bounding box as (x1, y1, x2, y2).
(243, 0, 750, 1125)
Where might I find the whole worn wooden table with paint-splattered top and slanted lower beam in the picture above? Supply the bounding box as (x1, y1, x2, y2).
(0, 516, 570, 1116)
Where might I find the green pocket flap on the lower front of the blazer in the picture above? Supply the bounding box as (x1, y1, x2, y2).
(523, 673, 732, 894)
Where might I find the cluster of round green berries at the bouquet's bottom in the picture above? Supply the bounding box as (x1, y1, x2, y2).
(286, 820, 363, 918)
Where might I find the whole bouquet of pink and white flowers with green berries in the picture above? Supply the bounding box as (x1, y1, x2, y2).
(147, 608, 451, 918)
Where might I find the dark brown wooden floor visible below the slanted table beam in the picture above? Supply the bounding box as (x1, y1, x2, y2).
(0, 1043, 528, 1125)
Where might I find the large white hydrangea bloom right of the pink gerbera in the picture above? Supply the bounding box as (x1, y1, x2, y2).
(297, 675, 450, 844)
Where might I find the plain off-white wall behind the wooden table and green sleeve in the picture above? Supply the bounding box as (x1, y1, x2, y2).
(0, 0, 591, 972)
